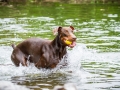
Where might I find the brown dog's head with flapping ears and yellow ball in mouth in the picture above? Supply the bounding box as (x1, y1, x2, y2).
(53, 26, 76, 48)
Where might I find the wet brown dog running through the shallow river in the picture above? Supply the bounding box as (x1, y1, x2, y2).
(11, 26, 76, 68)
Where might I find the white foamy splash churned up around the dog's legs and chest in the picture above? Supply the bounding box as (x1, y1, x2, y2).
(0, 45, 92, 76)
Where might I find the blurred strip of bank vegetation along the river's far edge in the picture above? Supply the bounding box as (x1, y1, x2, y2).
(0, 0, 120, 5)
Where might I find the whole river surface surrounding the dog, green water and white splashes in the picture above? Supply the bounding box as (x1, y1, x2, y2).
(0, 3, 120, 90)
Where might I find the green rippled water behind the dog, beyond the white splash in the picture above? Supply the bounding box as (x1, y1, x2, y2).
(0, 3, 120, 51)
